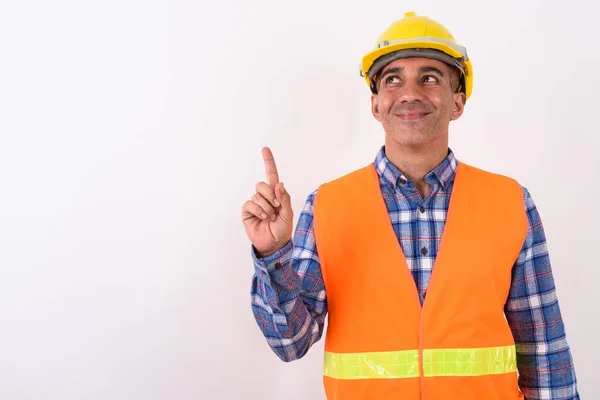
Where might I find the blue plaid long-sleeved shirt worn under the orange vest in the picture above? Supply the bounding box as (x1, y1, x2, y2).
(251, 147, 579, 400)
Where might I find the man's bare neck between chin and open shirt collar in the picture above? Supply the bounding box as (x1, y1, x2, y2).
(385, 135, 448, 198)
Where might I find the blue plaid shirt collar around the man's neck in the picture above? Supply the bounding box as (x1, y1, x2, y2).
(374, 146, 458, 189)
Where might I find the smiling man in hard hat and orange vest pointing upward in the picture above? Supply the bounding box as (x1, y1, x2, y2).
(242, 13, 579, 400)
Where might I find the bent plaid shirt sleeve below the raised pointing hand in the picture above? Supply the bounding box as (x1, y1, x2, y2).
(251, 191, 327, 362)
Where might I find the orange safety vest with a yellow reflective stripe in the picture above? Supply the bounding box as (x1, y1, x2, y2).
(314, 163, 527, 400)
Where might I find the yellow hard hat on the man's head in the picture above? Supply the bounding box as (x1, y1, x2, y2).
(360, 12, 473, 99)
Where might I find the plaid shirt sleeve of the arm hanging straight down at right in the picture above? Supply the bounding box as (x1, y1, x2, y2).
(505, 188, 579, 400)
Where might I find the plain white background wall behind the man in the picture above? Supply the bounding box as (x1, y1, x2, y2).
(0, 0, 600, 400)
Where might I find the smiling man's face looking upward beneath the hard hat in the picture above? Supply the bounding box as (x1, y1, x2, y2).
(371, 58, 465, 147)
